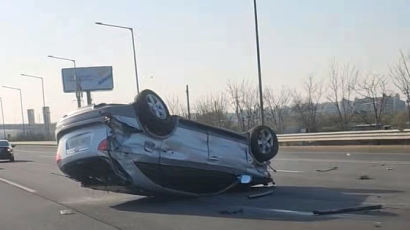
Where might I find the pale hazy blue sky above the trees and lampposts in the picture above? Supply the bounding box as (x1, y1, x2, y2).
(0, 0, 410, 123)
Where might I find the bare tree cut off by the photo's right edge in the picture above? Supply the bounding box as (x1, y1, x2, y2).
(390, 51, 410, 124)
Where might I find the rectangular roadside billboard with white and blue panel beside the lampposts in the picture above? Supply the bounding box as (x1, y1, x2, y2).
(61, 66, 114, 93)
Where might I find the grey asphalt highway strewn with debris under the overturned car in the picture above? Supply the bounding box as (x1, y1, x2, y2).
(0, 146, 410, 230)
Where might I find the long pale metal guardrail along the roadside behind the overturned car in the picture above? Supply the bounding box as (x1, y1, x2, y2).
(12, 129, 410, 146)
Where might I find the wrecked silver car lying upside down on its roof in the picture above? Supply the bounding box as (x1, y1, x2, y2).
(56, 90, 278, 196)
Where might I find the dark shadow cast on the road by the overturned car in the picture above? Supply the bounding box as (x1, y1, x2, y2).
(112, 186, 401, 221)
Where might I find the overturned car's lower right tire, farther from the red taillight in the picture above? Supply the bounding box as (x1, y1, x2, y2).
(251, 125, 279, 162)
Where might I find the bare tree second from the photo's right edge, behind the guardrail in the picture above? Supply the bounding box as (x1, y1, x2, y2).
(355, 74, 388, 126)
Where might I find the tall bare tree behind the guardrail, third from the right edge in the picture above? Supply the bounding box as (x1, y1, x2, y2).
(327, 61, 359, 130)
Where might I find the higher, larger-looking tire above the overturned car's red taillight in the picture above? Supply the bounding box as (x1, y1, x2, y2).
(134, 89, 175, 136)
